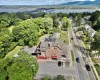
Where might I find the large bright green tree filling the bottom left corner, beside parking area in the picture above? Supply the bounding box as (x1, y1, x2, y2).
(0, 51, 39, 80)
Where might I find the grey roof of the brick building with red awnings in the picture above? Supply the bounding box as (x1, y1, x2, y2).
(40, 33, 63, 51)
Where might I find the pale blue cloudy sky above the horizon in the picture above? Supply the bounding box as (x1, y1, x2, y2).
(0, 0, 95, 5)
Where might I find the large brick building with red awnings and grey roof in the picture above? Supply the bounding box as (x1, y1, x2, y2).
(36, 33, 66, 59)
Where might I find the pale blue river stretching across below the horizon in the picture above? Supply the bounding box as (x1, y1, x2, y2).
(0, 8, 96, 13)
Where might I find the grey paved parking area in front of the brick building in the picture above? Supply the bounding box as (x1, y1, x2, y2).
(36, 60, 77, 79)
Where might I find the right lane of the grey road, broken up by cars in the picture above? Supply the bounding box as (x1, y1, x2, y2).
(77, 29, 96, 80)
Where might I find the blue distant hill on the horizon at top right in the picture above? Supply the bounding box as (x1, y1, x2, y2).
(59, 0, 100, 6)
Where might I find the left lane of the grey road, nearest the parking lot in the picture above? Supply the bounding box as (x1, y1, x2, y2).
(69, 28, 89, 80)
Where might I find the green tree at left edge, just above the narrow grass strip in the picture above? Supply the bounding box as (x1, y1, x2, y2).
(0, 28, 12, 58)
